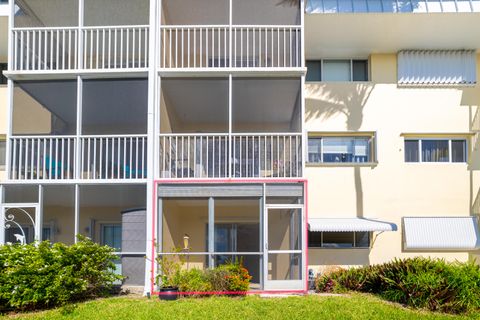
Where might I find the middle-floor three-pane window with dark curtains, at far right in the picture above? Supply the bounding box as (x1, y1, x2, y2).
(405, 139, 467, 162)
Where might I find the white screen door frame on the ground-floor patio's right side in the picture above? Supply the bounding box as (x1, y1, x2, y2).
(263, 204, 305, 290)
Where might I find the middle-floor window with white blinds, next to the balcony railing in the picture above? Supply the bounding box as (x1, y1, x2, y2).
(308, 136, 373, 163)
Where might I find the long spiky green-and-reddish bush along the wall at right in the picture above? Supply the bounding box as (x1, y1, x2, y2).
(316, 257, 480, 313)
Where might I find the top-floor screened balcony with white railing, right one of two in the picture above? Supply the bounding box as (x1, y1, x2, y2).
(158, 0, 303, 73)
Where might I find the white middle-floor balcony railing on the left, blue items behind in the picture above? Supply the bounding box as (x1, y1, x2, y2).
(9, 135, 147, 180)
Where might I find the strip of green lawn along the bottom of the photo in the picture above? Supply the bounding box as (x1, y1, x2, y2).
(0, 294, 480, 320)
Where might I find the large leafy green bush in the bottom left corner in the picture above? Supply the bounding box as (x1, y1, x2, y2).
(0, 237, 121, 311)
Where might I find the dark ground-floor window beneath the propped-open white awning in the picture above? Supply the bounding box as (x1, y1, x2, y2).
(308, 231, 370, 249)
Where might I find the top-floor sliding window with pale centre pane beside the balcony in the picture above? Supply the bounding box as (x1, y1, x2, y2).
(306, 59, 368, 82)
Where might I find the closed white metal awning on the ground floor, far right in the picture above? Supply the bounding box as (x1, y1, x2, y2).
(403, 217, 480, 250)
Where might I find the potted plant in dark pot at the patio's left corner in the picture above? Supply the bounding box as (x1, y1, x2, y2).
(156, 249, 185, 300)
